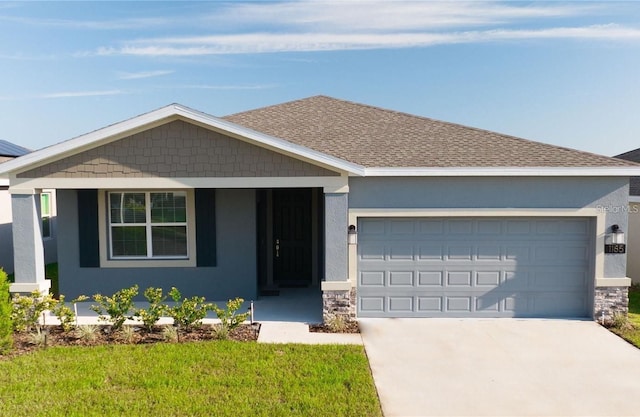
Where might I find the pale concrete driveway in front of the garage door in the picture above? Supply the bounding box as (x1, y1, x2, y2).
(359, 319, 640, 417)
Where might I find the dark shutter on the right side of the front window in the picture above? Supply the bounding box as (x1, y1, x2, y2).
(195, 188, 216, 266)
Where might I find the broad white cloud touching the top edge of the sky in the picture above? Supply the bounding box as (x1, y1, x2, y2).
(216, 0, 602, 32)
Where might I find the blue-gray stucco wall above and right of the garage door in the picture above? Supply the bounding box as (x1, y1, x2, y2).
(349, 177, 629, 278)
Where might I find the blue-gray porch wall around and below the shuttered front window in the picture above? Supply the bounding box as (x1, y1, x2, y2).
(58, 189, 257, 300)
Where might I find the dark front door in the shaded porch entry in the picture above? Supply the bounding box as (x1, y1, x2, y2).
(273, 188, 312, 287)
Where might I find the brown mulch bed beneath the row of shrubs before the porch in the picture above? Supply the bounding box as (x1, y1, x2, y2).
(0, 324, 259, 360)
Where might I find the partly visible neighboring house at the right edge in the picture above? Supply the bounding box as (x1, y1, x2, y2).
(614, 148, 640, 284)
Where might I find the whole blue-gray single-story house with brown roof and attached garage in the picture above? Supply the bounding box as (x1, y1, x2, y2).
(0, 96, 640, 319)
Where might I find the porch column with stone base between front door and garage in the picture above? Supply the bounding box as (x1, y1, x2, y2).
(321, 190, 355, 322)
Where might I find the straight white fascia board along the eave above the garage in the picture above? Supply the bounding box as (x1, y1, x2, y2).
(364, 167, 640, 177)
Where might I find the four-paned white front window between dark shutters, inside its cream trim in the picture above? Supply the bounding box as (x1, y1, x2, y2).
(109, 191, 188, 259)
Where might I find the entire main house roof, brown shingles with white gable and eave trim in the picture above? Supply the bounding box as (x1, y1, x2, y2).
(0, 96, 640, 177)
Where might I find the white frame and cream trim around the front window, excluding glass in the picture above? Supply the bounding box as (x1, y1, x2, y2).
(98, 189, 196, 268)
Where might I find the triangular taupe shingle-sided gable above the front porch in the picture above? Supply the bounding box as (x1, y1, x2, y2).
(18, 121, 340, 178)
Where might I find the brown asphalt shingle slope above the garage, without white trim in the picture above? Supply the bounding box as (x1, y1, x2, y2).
(224, 96, 636, 168)
